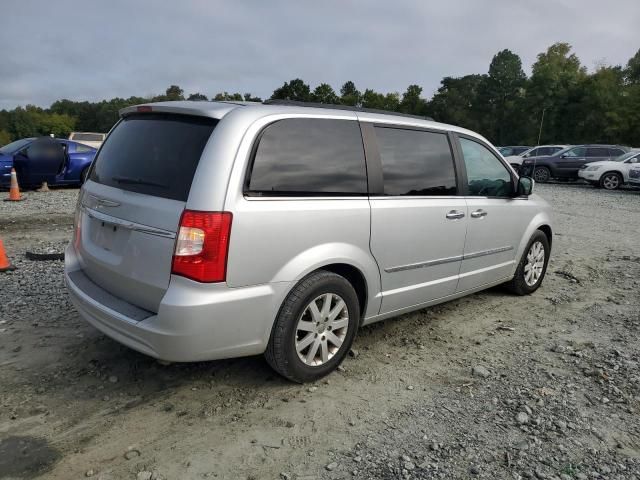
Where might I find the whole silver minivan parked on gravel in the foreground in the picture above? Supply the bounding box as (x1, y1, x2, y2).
(65, 102, 552, 382)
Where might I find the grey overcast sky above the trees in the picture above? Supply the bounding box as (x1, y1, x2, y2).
(0, 0, 640, 109)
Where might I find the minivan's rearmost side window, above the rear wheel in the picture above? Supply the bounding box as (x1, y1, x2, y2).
(249, 118, 367, 195)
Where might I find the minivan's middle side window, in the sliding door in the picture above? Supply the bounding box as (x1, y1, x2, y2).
(375, 127, 456, 195)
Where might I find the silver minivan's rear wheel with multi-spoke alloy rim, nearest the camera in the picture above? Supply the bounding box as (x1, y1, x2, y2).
(265, 270, 360, 383)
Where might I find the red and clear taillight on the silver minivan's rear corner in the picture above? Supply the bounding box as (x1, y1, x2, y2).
(171, 210, 232, 282)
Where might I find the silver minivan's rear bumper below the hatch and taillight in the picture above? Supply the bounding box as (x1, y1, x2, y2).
(65, 245, 288, 362)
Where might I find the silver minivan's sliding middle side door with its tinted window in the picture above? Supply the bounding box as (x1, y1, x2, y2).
(363, 124, 467, 313)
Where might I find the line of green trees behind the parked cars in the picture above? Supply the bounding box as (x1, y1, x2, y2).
(0, 43, 640, 146)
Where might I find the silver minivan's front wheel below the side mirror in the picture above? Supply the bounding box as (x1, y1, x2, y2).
(507, 230, 551, 295)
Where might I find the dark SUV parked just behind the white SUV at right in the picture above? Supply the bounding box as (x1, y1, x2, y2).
(521, 145, 629, 182)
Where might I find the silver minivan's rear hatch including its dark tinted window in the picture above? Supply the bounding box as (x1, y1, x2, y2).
(75, 113, 218, 312)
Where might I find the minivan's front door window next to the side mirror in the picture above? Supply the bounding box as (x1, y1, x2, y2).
(460, 138, 513, 197)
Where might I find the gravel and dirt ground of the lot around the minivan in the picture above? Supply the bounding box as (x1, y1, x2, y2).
(0, 184, 640, 480)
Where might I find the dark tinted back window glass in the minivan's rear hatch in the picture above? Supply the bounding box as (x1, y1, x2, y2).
(89, 113, 218, 201)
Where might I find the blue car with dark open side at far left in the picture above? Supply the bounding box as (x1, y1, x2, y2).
(0, 137, 97, 187)
